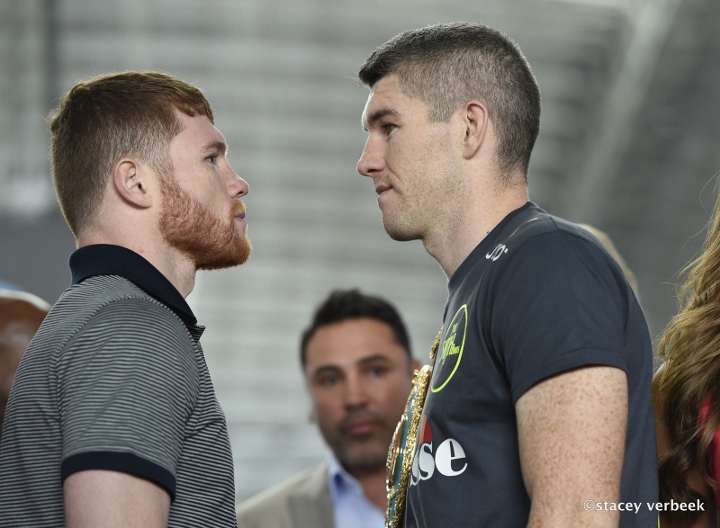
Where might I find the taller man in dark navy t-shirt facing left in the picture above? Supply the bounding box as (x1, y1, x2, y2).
(358, 23, 657, 528)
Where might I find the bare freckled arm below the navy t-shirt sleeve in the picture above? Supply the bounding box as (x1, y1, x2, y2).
(516, 367, 628, 527)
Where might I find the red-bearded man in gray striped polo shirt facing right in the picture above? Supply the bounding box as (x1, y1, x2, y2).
(0, 72, 250, 528)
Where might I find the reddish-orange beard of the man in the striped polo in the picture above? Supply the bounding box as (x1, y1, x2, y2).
(159, 175, 252, 270)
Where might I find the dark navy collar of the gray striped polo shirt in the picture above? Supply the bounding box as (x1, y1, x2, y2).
(70, 244, 197, 326)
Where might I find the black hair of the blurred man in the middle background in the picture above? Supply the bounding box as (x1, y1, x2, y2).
(300, 289, 412, 368)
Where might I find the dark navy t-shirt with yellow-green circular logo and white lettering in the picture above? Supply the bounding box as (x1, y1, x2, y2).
(406, 203, 658, 528)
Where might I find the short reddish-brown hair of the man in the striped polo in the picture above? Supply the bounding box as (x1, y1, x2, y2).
(47, 71, 213, 236)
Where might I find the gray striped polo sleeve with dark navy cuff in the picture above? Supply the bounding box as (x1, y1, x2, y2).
(55, 299, 199, 498)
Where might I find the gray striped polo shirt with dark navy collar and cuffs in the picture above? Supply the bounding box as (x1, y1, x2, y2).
(0, 245, 236, 528)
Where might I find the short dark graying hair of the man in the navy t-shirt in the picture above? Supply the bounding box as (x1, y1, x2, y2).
(358, 22, 540, 179)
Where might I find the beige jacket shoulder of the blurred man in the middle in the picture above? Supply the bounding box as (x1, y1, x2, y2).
(237, 463, 330, 527)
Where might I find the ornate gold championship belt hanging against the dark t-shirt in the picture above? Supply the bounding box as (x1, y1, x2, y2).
(385, 329, 442, 528)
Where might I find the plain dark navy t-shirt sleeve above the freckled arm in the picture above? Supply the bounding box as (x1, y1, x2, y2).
(486, 231, 632, 402)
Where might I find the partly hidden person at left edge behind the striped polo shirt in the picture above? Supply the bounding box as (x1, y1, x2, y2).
(0, 289, 50, 438)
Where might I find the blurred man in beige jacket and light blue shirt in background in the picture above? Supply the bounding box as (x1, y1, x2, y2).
(238, 290, 418, 528)
